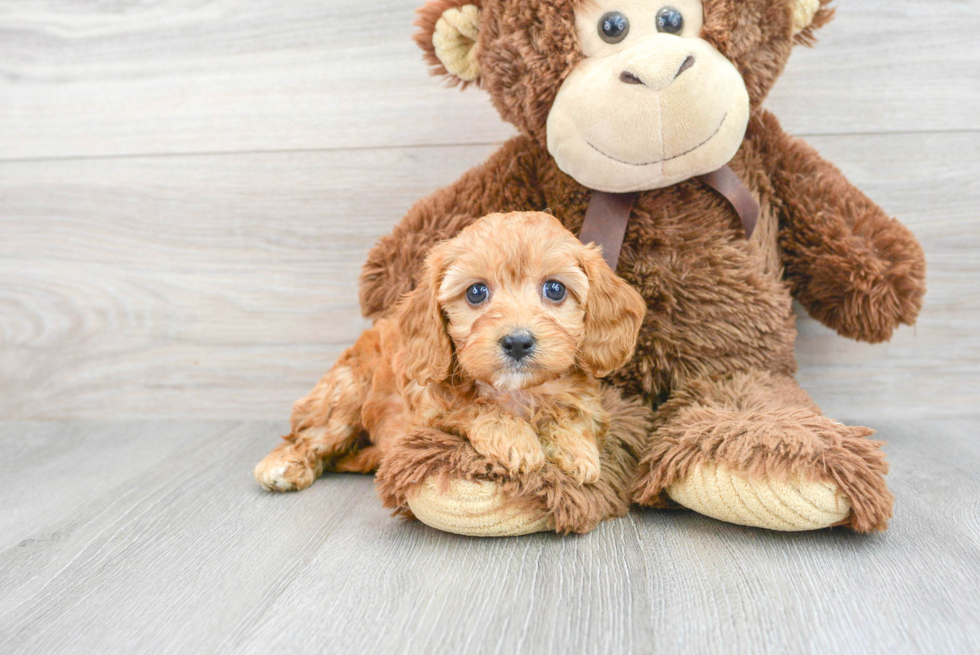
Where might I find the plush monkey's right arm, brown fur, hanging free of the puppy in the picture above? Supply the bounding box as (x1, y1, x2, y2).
(761, 114, 926, 343)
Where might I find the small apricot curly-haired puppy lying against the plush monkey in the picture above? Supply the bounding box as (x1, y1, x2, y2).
(255, 212, 646, 491)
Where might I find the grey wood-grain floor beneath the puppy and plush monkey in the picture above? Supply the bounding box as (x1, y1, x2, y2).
(0, 419, 980, 655)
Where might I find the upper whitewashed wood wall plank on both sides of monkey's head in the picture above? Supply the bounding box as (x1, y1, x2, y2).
(0, 0, 980, 159)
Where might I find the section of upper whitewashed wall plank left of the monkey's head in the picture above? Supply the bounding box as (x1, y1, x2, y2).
(0, 0, 511, 158)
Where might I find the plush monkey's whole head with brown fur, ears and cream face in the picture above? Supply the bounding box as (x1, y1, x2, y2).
(416, 0, 833, 187)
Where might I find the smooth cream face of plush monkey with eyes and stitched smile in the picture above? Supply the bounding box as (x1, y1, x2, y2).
(547, 0, 749, 192)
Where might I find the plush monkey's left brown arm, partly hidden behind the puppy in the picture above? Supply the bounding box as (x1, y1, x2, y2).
(360, 136, 544, 319)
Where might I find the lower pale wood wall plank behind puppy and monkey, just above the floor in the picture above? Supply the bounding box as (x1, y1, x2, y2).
(0, 133, 980, 420)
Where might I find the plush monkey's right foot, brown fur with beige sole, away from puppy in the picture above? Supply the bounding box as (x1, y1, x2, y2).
(633, 386, 894, 534)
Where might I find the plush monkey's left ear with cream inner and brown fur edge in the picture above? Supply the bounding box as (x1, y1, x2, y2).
(415, 0, 480, 87)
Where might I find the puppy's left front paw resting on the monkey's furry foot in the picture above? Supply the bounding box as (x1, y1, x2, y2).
(467, 410, 544, 473)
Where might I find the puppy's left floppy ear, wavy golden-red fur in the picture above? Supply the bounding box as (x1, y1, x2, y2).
(395, 246, 453, 385)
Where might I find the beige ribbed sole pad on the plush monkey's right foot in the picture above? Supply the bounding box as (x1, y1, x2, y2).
(667, 464, 851, 532)
